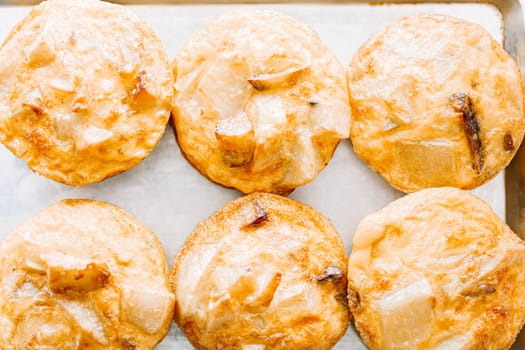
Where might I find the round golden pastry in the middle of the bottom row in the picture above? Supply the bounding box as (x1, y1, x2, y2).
(171, 193, 348, 350)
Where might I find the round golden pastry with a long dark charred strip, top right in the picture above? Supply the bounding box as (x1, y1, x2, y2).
(348, 15, 525, 192)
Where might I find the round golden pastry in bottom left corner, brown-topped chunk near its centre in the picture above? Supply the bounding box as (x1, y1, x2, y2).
(0, 199, 174, 349)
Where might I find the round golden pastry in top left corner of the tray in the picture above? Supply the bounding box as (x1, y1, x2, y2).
(0, 0, 173, 186)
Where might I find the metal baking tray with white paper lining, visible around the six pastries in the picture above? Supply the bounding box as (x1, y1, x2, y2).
(0, 0, 525, 350)
